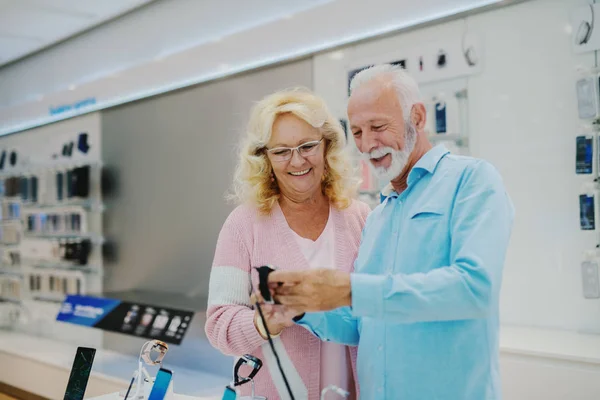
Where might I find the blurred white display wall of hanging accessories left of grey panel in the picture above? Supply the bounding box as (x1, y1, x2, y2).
(0, 114, 104, 345)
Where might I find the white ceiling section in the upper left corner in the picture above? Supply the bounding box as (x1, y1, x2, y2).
(0, 0, 153, 66)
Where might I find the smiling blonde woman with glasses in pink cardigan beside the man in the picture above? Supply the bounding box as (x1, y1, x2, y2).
(205, 89, 370, 399)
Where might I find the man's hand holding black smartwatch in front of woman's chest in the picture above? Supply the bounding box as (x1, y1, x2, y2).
(269, 269, 352, 313)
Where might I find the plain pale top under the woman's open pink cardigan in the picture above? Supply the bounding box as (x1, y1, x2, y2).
(290, 213, 354, 399)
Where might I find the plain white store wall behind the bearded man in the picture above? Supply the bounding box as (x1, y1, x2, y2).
(314, 0, 600, 331)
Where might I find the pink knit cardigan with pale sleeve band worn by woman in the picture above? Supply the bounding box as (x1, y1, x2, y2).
(205, 201, 370, 400)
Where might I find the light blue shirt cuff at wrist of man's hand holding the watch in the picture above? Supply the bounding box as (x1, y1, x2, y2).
(350, 273, 386, 317)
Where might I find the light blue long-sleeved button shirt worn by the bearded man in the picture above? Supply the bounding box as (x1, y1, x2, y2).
(298, 145, 514, 400)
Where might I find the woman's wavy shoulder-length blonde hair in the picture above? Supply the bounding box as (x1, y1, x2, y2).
(229, 88, 360, 214)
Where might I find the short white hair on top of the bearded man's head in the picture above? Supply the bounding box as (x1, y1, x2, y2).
(350, 64, 421, 121)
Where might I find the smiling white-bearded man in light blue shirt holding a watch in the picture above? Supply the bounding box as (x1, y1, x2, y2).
(269, 65, 514, 400)
